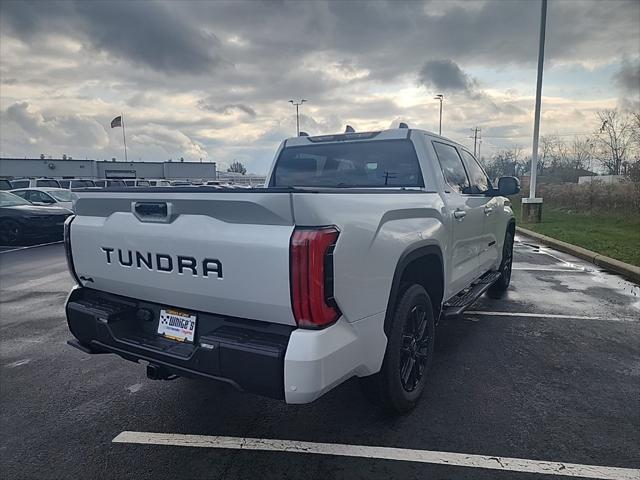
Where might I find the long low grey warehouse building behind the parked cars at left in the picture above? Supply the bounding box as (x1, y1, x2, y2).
(0, 158, 216, 180)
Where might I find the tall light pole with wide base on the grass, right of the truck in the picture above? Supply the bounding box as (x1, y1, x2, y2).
(522, 0, 547, 223)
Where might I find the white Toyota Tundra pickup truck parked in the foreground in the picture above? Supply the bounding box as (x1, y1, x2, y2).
(65, 125, 519, 412)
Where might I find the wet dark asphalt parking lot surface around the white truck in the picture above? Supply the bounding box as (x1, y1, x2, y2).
(0, 237, 640, 479)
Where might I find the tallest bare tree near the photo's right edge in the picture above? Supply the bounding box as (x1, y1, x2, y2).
(596, 110, 634, 175)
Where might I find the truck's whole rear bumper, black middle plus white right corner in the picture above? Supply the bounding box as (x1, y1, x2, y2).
(66, 286, 386, 404)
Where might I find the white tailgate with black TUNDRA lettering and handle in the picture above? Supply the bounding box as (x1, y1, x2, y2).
(71, 189, 295, 325)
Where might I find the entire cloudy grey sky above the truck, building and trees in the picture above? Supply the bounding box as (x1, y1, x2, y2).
(0, 0, 640, 173)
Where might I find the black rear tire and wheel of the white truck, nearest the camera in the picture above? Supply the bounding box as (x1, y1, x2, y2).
(362, 284, 435, 415)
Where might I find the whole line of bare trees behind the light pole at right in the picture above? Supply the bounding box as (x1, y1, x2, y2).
(483, 109, 640, 183)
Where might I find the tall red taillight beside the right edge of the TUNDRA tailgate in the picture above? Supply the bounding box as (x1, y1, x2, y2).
(291, 227, 340, 328)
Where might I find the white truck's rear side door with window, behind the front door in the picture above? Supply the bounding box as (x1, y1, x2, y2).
(432, 141, 484, 293)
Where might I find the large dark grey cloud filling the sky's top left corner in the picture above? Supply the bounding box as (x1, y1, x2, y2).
(2, 0, 228, 73)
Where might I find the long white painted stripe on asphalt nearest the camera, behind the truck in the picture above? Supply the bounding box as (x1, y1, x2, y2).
(113, 431, 640, 480)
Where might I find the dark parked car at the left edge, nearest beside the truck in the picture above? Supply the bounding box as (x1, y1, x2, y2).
(0, 191, 72, 245)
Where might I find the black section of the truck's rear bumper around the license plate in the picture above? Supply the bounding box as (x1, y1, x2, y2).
(66, 287, 293, 399)
